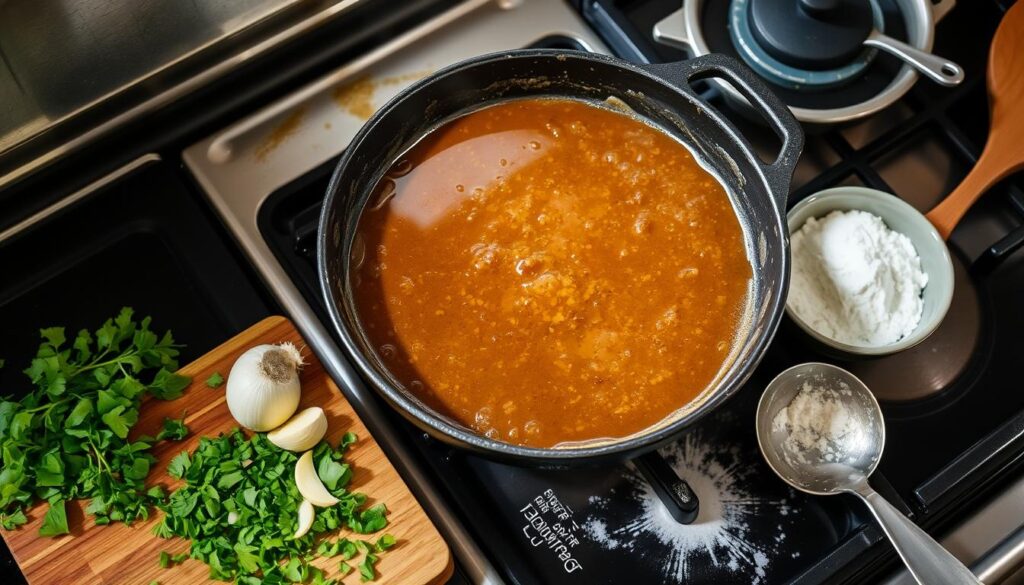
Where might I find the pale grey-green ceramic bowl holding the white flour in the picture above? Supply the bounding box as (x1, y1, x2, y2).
(785, 186, 953, 357)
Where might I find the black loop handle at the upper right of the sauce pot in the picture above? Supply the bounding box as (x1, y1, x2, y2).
(640, 53, 804, 213)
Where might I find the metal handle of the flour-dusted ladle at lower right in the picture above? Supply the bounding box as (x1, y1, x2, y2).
(854, 482, 981, 585)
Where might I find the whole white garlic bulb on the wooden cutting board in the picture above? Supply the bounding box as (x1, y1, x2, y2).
(225, 342, 302, 431)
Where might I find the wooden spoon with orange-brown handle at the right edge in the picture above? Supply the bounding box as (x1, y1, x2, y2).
(927, 2, 1024, 239)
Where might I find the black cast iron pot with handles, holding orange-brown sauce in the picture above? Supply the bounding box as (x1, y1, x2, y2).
(316, 49, 803, 521)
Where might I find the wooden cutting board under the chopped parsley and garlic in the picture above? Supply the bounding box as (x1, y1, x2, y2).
(0, 317, 453, 585)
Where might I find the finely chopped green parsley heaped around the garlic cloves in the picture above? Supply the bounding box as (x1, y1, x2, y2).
(154, 428, 395, 585)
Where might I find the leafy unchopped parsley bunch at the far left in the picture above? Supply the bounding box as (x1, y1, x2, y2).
(0, 307, 190, 536)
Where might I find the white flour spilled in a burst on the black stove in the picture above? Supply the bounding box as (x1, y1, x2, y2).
(583, 432, 790, 585)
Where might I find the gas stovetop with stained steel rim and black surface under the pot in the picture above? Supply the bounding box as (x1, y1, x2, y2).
(184, 0, 1024, 584)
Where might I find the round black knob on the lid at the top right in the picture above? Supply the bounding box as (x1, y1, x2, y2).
(750, 0, 873, 70)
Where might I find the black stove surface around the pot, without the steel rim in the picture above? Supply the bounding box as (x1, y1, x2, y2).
(259, 0, 1024, 584)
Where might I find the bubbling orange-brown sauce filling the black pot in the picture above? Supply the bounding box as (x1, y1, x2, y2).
(352, 99, 751, 447)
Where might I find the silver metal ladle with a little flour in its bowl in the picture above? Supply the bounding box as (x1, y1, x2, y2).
(757, 363, 981, 585)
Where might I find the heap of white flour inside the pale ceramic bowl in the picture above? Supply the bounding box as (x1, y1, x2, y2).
(788, 211, 928, 346)
